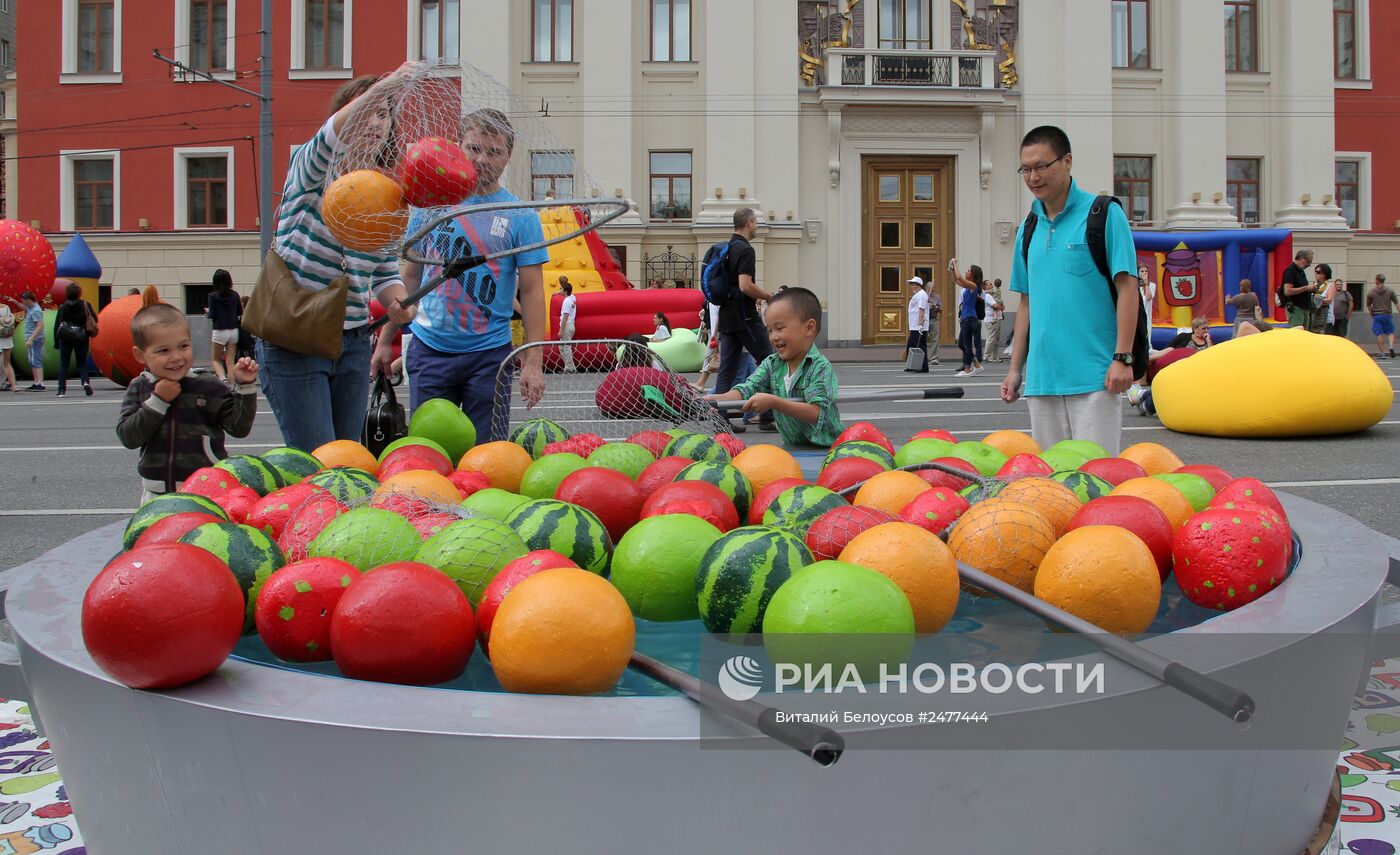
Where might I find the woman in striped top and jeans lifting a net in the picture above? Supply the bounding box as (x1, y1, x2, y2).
(258, 70, 414, 451)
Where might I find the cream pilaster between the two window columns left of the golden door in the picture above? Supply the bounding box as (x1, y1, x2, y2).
(574, 0, 647, 224)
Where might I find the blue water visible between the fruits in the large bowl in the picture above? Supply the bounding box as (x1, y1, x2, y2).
(224, 451, 1302, 697)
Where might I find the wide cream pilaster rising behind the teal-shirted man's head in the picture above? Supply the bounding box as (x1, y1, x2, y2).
(1016, 0, 1113, 195)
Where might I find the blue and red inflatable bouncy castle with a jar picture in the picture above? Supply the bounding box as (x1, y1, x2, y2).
(1133, 228, 1294, 347)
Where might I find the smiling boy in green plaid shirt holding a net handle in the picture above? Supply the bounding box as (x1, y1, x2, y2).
(707, 288, 846, 448)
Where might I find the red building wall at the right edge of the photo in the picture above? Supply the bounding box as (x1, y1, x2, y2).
(1336, 0, 1400, 234)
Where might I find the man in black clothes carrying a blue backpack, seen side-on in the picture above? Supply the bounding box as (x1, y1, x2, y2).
(701, 207, 777, 431)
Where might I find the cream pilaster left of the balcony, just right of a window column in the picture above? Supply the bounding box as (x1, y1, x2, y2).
(692, 0, 756, 225)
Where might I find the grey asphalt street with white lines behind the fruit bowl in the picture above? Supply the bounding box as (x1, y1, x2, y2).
(0, 350, 1400, 570)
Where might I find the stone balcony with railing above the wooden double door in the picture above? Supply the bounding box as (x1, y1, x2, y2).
(822, 48, 1002, 104)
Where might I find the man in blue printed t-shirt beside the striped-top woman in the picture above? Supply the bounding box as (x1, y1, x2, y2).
(374, 109, 549, 442)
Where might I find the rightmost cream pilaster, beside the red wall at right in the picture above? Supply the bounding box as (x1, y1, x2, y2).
(1264, 0, 1347, 229)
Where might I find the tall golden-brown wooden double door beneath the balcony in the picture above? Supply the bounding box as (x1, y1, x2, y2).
(861, 155, 956, 344)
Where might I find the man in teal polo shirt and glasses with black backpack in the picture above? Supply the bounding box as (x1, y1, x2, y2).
(1001, 125, 1138, 455)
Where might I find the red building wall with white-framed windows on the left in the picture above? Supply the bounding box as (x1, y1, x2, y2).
(17, 0, 407, 232)
